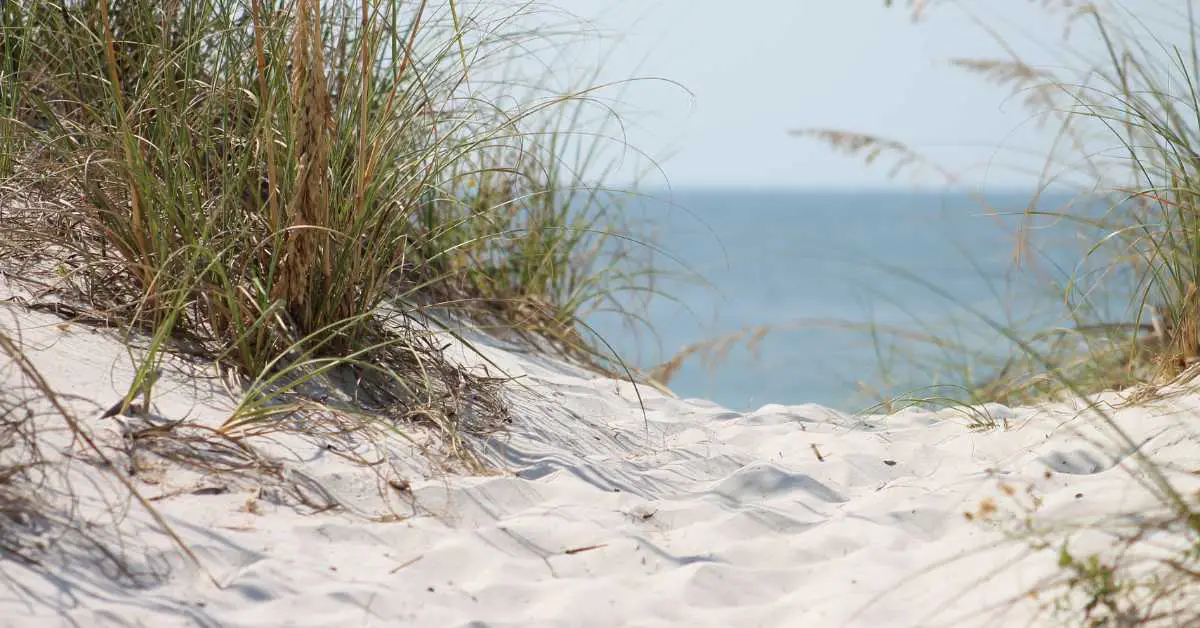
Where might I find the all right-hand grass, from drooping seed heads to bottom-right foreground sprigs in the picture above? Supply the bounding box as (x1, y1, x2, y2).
(638, 0, 1200, 626)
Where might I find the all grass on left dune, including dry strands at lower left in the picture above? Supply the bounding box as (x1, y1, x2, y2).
(0, 0, 654, 567)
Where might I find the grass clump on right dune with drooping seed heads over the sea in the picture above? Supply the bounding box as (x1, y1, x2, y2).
(724, 1, 1200, 405)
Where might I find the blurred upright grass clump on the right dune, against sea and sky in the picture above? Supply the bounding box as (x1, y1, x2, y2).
(835, 1, 1200, 401)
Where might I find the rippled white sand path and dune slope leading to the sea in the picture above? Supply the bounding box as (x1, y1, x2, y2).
(0, 298, 1200, 627)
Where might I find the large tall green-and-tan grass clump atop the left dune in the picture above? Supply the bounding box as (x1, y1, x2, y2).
(0, 0, 646, 432)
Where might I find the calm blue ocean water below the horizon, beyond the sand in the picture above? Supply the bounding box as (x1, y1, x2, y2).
(588, 190, 1134, 411)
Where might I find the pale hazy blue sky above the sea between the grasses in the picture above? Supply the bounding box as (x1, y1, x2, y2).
(535, 0, 1152, 187)
